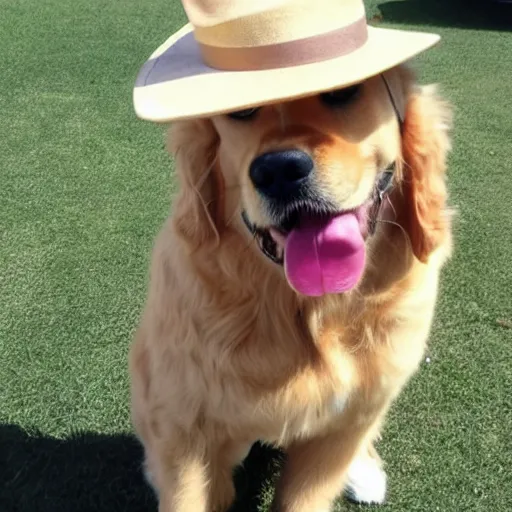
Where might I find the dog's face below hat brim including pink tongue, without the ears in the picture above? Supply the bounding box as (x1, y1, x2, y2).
(208, 77, 408, 295)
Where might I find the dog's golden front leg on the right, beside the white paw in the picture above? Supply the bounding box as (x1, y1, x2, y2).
(272, 404, 387, 512)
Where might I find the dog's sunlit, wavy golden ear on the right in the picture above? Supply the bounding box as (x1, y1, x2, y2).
(400, 86, 451, 263)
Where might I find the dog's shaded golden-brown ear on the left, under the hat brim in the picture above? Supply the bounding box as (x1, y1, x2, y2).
(168, 119, 224, 250)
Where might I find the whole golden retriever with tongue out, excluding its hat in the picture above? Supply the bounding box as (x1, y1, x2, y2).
(130, 66, 452, 512)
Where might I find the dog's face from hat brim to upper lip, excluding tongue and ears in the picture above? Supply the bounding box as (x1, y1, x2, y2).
(213, 77, 400, 235)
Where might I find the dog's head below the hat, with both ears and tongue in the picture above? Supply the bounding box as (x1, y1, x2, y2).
(171, 67, 449, 295)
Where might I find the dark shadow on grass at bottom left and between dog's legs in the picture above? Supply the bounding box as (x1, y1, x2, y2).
(0, 425, 280, 512)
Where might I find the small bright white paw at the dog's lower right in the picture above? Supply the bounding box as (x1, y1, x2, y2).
(345, 457, 387, 504)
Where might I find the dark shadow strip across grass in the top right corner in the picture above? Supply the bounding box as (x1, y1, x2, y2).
(378, 0, 512, 31)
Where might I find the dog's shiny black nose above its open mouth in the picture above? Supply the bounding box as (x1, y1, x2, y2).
(249, 149, 314, 199)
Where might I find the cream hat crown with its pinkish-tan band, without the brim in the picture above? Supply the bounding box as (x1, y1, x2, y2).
(182, 0, 367, 71)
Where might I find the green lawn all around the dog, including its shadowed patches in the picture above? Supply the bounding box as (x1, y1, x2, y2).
(0, 0, 512, 512)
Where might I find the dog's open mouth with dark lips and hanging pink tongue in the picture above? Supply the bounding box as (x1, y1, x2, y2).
(242, 169, 393, 296)
